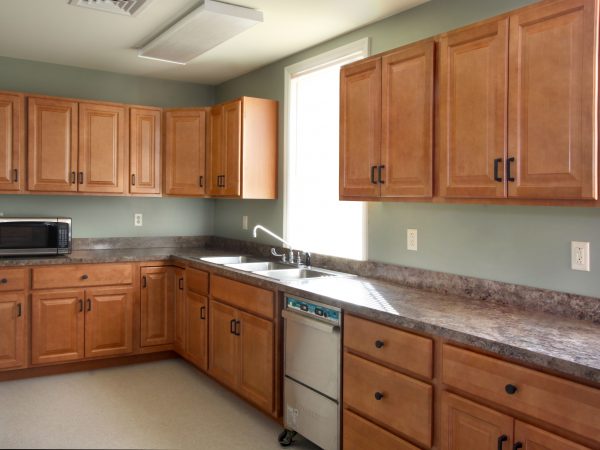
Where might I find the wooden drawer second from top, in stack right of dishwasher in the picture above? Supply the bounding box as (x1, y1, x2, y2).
(344, 352, 433, 447)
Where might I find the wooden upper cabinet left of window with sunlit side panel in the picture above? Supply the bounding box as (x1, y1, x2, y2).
(206, 97, 277, 199)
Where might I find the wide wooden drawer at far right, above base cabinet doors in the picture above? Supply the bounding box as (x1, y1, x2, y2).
(442, 344, 600, 442)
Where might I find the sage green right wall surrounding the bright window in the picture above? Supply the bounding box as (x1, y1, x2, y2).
(215, 0, 600, 297)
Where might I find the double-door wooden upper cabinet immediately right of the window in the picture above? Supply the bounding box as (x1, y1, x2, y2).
(340, 40, 435, 199)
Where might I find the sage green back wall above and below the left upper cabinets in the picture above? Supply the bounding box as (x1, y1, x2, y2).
(0, 57, 215, 237)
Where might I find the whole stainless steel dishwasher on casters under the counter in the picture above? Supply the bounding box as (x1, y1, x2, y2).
(279, 295, 342, 450)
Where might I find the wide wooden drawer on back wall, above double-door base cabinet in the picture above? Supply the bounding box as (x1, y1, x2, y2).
(31, 264, 133, 289)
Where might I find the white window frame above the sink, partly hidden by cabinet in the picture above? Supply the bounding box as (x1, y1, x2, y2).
(283, 37, 371, 260)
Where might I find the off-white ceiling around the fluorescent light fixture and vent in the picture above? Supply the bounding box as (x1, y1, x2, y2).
(0, 0, 428, 84)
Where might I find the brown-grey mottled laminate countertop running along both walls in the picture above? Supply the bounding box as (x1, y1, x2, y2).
(0, 248, 600, 384)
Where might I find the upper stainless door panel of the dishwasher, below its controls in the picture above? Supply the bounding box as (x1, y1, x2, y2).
(282, 310, 341, 401)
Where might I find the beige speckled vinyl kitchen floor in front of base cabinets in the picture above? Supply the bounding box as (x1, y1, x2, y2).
(0, 359, 318, 450)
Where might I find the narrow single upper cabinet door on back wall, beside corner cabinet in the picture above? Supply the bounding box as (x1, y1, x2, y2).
(129, 108, 161, 194)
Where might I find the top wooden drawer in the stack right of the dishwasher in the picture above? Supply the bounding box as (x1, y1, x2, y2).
(344, 315, 433, 378)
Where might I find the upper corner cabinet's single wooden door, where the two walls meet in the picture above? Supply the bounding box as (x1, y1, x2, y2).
(165, 109, 206, 195)
